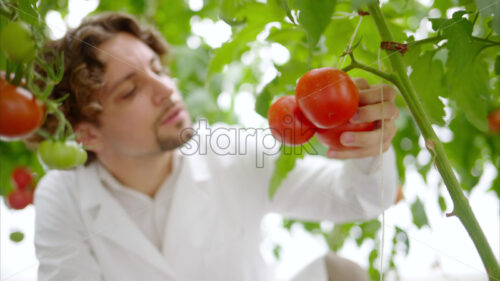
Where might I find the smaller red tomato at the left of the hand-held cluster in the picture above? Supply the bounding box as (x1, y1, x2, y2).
(267, 96, 316, 146)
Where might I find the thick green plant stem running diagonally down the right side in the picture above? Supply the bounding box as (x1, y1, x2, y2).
(368, 3, 500, 281)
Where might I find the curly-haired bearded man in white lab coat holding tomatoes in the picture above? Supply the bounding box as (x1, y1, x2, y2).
(35, 13, 398, 281)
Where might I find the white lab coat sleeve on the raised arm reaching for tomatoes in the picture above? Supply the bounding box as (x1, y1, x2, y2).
(265, 143, 398, 222)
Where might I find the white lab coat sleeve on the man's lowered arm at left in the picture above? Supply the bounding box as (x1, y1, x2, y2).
(34, 171, 102, 281)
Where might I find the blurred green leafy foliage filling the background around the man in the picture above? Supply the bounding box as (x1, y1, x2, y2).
(0, 0, 500, 280)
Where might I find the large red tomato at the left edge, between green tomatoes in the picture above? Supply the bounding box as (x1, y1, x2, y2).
(0, 78, 45, 138)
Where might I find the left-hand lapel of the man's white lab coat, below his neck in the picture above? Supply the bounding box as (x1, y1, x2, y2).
(77, 164, 178, 278)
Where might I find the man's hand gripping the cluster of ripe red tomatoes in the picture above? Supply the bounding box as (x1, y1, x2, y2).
(326, 78, 399, 159)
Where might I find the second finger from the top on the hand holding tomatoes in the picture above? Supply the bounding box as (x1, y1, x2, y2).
(350, 101, 399, 123)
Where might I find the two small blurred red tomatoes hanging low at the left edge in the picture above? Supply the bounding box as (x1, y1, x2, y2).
(6, 166, 36, 210)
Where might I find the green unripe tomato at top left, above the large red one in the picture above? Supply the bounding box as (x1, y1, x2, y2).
(0, 21, 36, 63)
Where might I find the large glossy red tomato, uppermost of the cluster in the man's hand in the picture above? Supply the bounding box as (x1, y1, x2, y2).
(295, 67, 359, 129)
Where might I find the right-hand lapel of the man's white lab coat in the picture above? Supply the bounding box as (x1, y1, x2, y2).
(163, 151, 217, 272)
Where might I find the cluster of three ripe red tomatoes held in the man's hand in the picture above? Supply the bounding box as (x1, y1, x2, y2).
(267, 67, 375, 150)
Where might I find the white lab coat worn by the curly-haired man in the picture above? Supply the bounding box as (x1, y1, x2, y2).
(35, 120, 397, 281)
